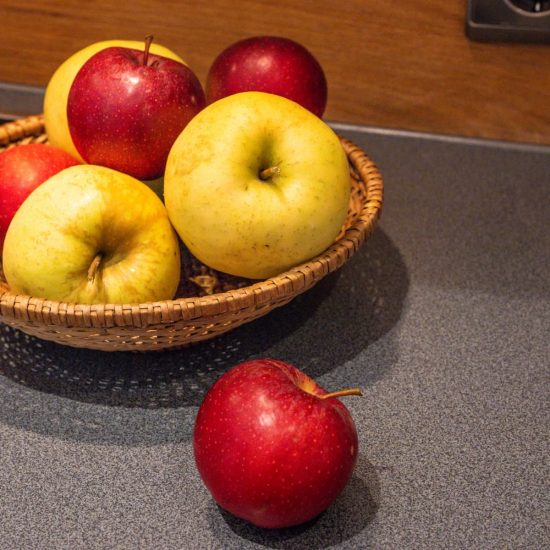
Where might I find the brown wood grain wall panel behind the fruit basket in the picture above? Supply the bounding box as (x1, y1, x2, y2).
(0, 0, 550, 144)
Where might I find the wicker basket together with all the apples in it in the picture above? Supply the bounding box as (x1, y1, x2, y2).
(0, 37, 383, 351)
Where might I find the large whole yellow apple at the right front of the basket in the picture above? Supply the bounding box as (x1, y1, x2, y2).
(164, 92, 350, 279)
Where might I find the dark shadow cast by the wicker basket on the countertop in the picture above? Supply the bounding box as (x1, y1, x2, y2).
(0, 228, 409, 414)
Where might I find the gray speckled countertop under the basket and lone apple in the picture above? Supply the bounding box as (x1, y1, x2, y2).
(0, 123, 550, 550)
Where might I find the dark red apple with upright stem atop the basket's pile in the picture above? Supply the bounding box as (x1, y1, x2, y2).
(67, 37, 205, 180)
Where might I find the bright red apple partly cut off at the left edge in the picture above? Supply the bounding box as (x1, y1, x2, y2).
(0, 143, 80, 251)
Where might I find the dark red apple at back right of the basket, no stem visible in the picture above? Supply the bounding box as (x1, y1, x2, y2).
(206, 36, 327, 117)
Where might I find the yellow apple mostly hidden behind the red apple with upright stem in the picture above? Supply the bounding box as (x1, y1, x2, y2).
(44, 40, 186, 162)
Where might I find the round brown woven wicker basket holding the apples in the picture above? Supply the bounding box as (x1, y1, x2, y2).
(0, 116, 383, 351)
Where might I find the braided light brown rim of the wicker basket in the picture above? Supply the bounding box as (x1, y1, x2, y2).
(0, 115, 383, 327)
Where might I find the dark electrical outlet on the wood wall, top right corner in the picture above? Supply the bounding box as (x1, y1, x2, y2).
(466, 0, 550, 43)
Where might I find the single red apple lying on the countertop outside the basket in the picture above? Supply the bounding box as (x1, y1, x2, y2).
(193, 359, 360, 528)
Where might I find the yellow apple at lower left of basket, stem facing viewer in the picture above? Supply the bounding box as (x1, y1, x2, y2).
(3, 165, 180, 304)
